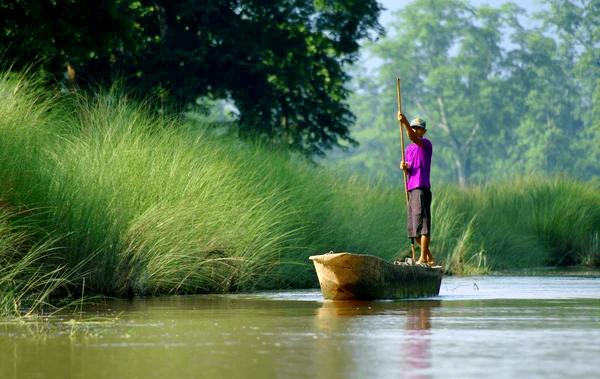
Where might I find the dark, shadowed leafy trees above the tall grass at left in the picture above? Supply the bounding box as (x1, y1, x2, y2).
(0, 0, 382, 155)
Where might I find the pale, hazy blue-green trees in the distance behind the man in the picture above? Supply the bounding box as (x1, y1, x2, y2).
(335, 0, 600, 185)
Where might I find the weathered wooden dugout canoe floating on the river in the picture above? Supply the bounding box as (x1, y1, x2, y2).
(309, 253, 442, 300)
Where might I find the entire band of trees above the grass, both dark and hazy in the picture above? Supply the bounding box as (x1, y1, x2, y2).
(0, 0, 600, 185)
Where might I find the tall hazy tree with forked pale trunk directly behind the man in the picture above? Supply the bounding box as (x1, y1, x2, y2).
(338, 0, 517, 185)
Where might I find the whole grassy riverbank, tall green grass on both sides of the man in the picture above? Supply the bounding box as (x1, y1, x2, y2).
(0, 73, 600, 313)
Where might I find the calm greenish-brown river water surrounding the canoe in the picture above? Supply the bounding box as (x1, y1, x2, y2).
(0, 276, 600, 379)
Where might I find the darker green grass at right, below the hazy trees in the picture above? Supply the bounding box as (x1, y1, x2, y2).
(458, 177, 600, 269)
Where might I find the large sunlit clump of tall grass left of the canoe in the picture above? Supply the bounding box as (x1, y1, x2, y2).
(0, 72, 408, 294)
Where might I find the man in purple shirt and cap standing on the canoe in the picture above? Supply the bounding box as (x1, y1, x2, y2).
(398, 112, 434, 266)
